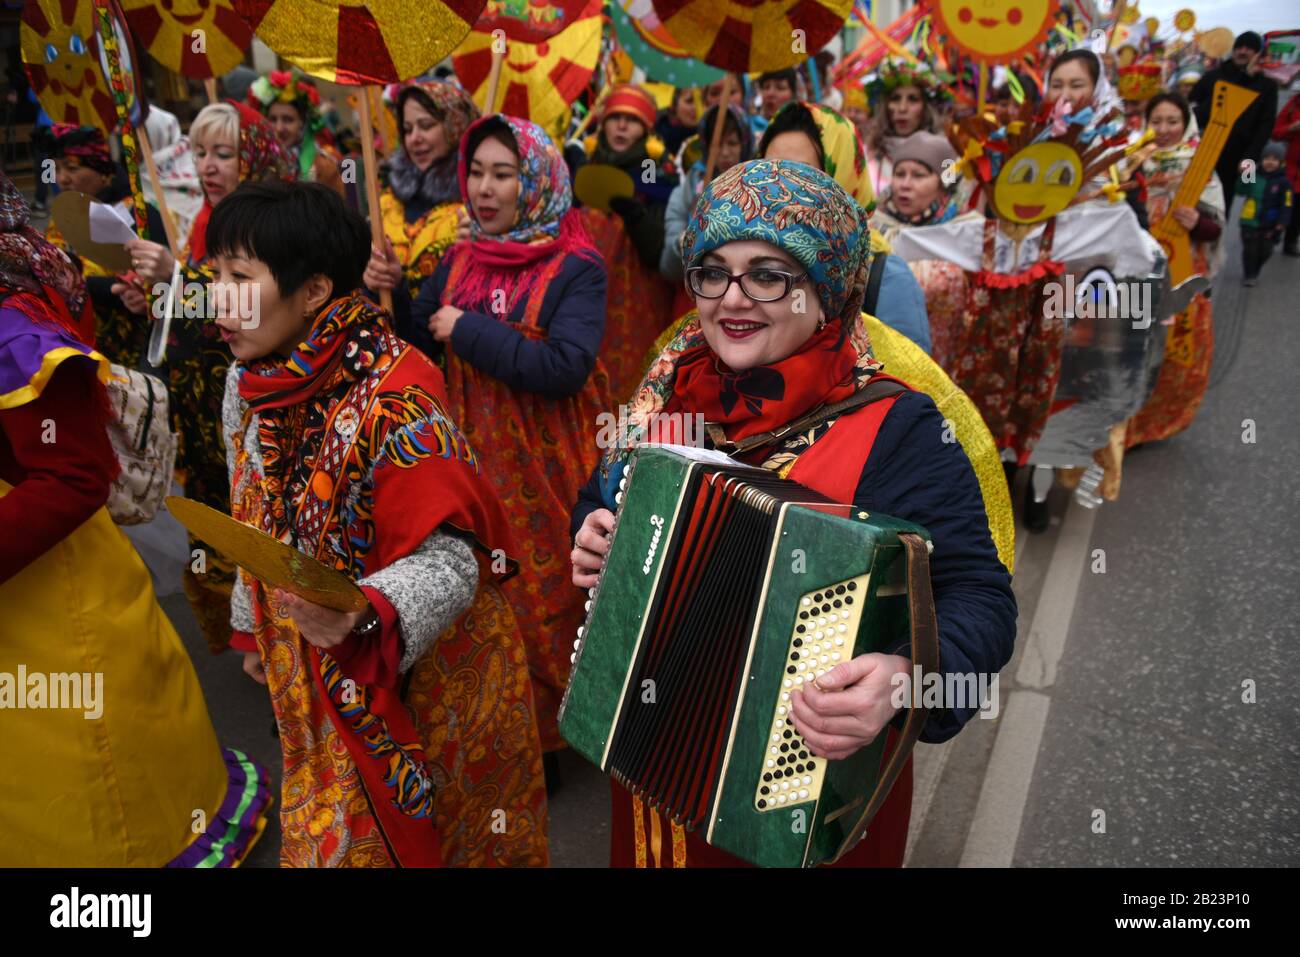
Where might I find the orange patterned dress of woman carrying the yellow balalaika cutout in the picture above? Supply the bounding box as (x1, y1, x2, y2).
(1115, 120, 1223, 449)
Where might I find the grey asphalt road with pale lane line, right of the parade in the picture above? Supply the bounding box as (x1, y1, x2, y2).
(909, 204, 1300, 867)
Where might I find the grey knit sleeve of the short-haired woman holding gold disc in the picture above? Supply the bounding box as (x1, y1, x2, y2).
(358, 532, 478, 671)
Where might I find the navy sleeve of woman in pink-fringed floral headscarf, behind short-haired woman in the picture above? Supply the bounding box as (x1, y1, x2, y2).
(447, 256, 606, 398)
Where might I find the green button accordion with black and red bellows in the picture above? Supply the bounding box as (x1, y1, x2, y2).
(559, 446, 939, 867)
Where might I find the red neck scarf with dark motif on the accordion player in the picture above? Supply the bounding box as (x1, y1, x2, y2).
(664, 322, 858, 442)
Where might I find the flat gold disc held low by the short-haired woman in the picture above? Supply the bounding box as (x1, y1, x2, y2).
(166, 495, 368, 611)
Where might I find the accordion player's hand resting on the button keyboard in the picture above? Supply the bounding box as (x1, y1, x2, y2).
(793, 654, 911, 761)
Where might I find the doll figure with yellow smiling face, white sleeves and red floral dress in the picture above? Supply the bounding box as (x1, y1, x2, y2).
(893, 101, 1154, 465)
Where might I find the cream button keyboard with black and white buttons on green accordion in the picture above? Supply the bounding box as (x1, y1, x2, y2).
(754, 575, 867, 811)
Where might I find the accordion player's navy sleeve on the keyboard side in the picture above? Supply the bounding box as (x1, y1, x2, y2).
(854, 393, 1017, 742)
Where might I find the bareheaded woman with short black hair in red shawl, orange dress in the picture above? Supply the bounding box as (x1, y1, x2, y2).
(208, 183, 546, 866)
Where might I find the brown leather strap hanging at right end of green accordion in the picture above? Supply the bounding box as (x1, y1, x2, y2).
(831, 533, 939, 863)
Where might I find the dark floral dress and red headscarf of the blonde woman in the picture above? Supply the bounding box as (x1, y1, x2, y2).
(166, 104, 295, 653)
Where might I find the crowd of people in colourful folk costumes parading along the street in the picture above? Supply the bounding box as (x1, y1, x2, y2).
(0, 13, 1300, 866)
